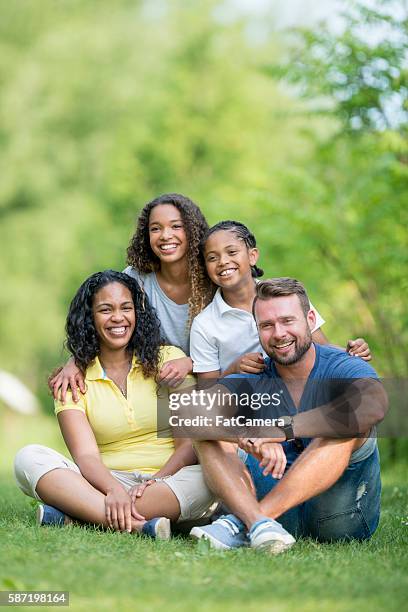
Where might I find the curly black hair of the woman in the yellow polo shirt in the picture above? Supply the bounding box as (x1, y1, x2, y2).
(65, 270, 163, 379)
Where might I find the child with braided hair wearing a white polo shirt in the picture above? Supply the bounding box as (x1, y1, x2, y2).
(190, 221, 371, 378)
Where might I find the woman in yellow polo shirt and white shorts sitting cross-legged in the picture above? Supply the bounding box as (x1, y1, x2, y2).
(15, 270, 214, 539)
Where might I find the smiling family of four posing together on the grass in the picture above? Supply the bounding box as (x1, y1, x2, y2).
(15, 194, 387, 553)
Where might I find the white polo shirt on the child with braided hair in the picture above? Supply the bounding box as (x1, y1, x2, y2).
(190, 288, 325, 372)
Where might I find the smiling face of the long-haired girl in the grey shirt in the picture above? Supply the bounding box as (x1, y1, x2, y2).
(149, 204, 188, 263)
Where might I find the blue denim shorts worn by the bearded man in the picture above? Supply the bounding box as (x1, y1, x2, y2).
(245, 442, 381, 542)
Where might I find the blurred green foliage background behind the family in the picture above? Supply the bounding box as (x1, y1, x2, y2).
(0, 0, 408, 462)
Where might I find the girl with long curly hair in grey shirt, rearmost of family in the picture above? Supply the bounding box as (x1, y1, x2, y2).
(50, 193, 213, 401)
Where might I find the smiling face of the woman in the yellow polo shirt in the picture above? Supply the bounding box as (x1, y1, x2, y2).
(92, 283, 136, 350)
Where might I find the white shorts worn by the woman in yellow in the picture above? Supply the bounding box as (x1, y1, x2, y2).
(14, 444, 217, 521)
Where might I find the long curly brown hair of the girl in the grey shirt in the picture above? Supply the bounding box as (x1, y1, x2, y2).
(127, 193, 214, 325)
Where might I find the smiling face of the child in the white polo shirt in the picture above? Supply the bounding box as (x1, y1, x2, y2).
(204, 230, 259, 289)
